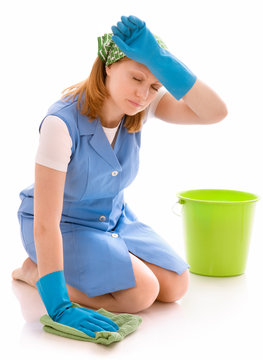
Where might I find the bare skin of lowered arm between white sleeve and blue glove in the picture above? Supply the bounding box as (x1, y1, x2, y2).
(34, 163, 66, 277)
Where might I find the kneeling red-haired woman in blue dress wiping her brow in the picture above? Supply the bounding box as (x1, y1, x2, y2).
(12, 16, 227, 336)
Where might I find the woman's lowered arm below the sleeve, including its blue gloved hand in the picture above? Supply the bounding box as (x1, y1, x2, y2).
(34, 164, 119, 337)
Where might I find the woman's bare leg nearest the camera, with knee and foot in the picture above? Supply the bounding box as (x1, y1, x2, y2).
(12, 254, 159, 313)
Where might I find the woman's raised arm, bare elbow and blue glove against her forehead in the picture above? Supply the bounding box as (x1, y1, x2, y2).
(112, 16, 227, 124)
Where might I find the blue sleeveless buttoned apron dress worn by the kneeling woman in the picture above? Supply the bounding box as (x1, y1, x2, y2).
(18, 95, 189, 297)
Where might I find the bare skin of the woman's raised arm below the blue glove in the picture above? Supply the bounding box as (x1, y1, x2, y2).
(155, 79, 227, 125)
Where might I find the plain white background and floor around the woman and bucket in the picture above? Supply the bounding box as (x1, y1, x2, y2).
(0, 0, 263, 359)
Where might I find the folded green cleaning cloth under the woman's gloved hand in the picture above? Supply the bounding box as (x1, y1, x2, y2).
(40, 303, 142, 345)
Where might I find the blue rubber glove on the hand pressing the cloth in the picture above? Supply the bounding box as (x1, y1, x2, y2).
(36, 270, 119, 338)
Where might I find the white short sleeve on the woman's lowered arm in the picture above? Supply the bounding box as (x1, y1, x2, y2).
(35, 115, 72, 172)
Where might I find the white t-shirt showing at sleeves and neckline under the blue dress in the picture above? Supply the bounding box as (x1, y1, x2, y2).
(35, 87, 167, 172)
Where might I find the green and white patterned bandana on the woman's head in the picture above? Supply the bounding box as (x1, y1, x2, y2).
(98, 33, 167, 66)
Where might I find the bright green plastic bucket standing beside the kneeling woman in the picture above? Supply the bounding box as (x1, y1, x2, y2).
(173, 189, 259, 276)
